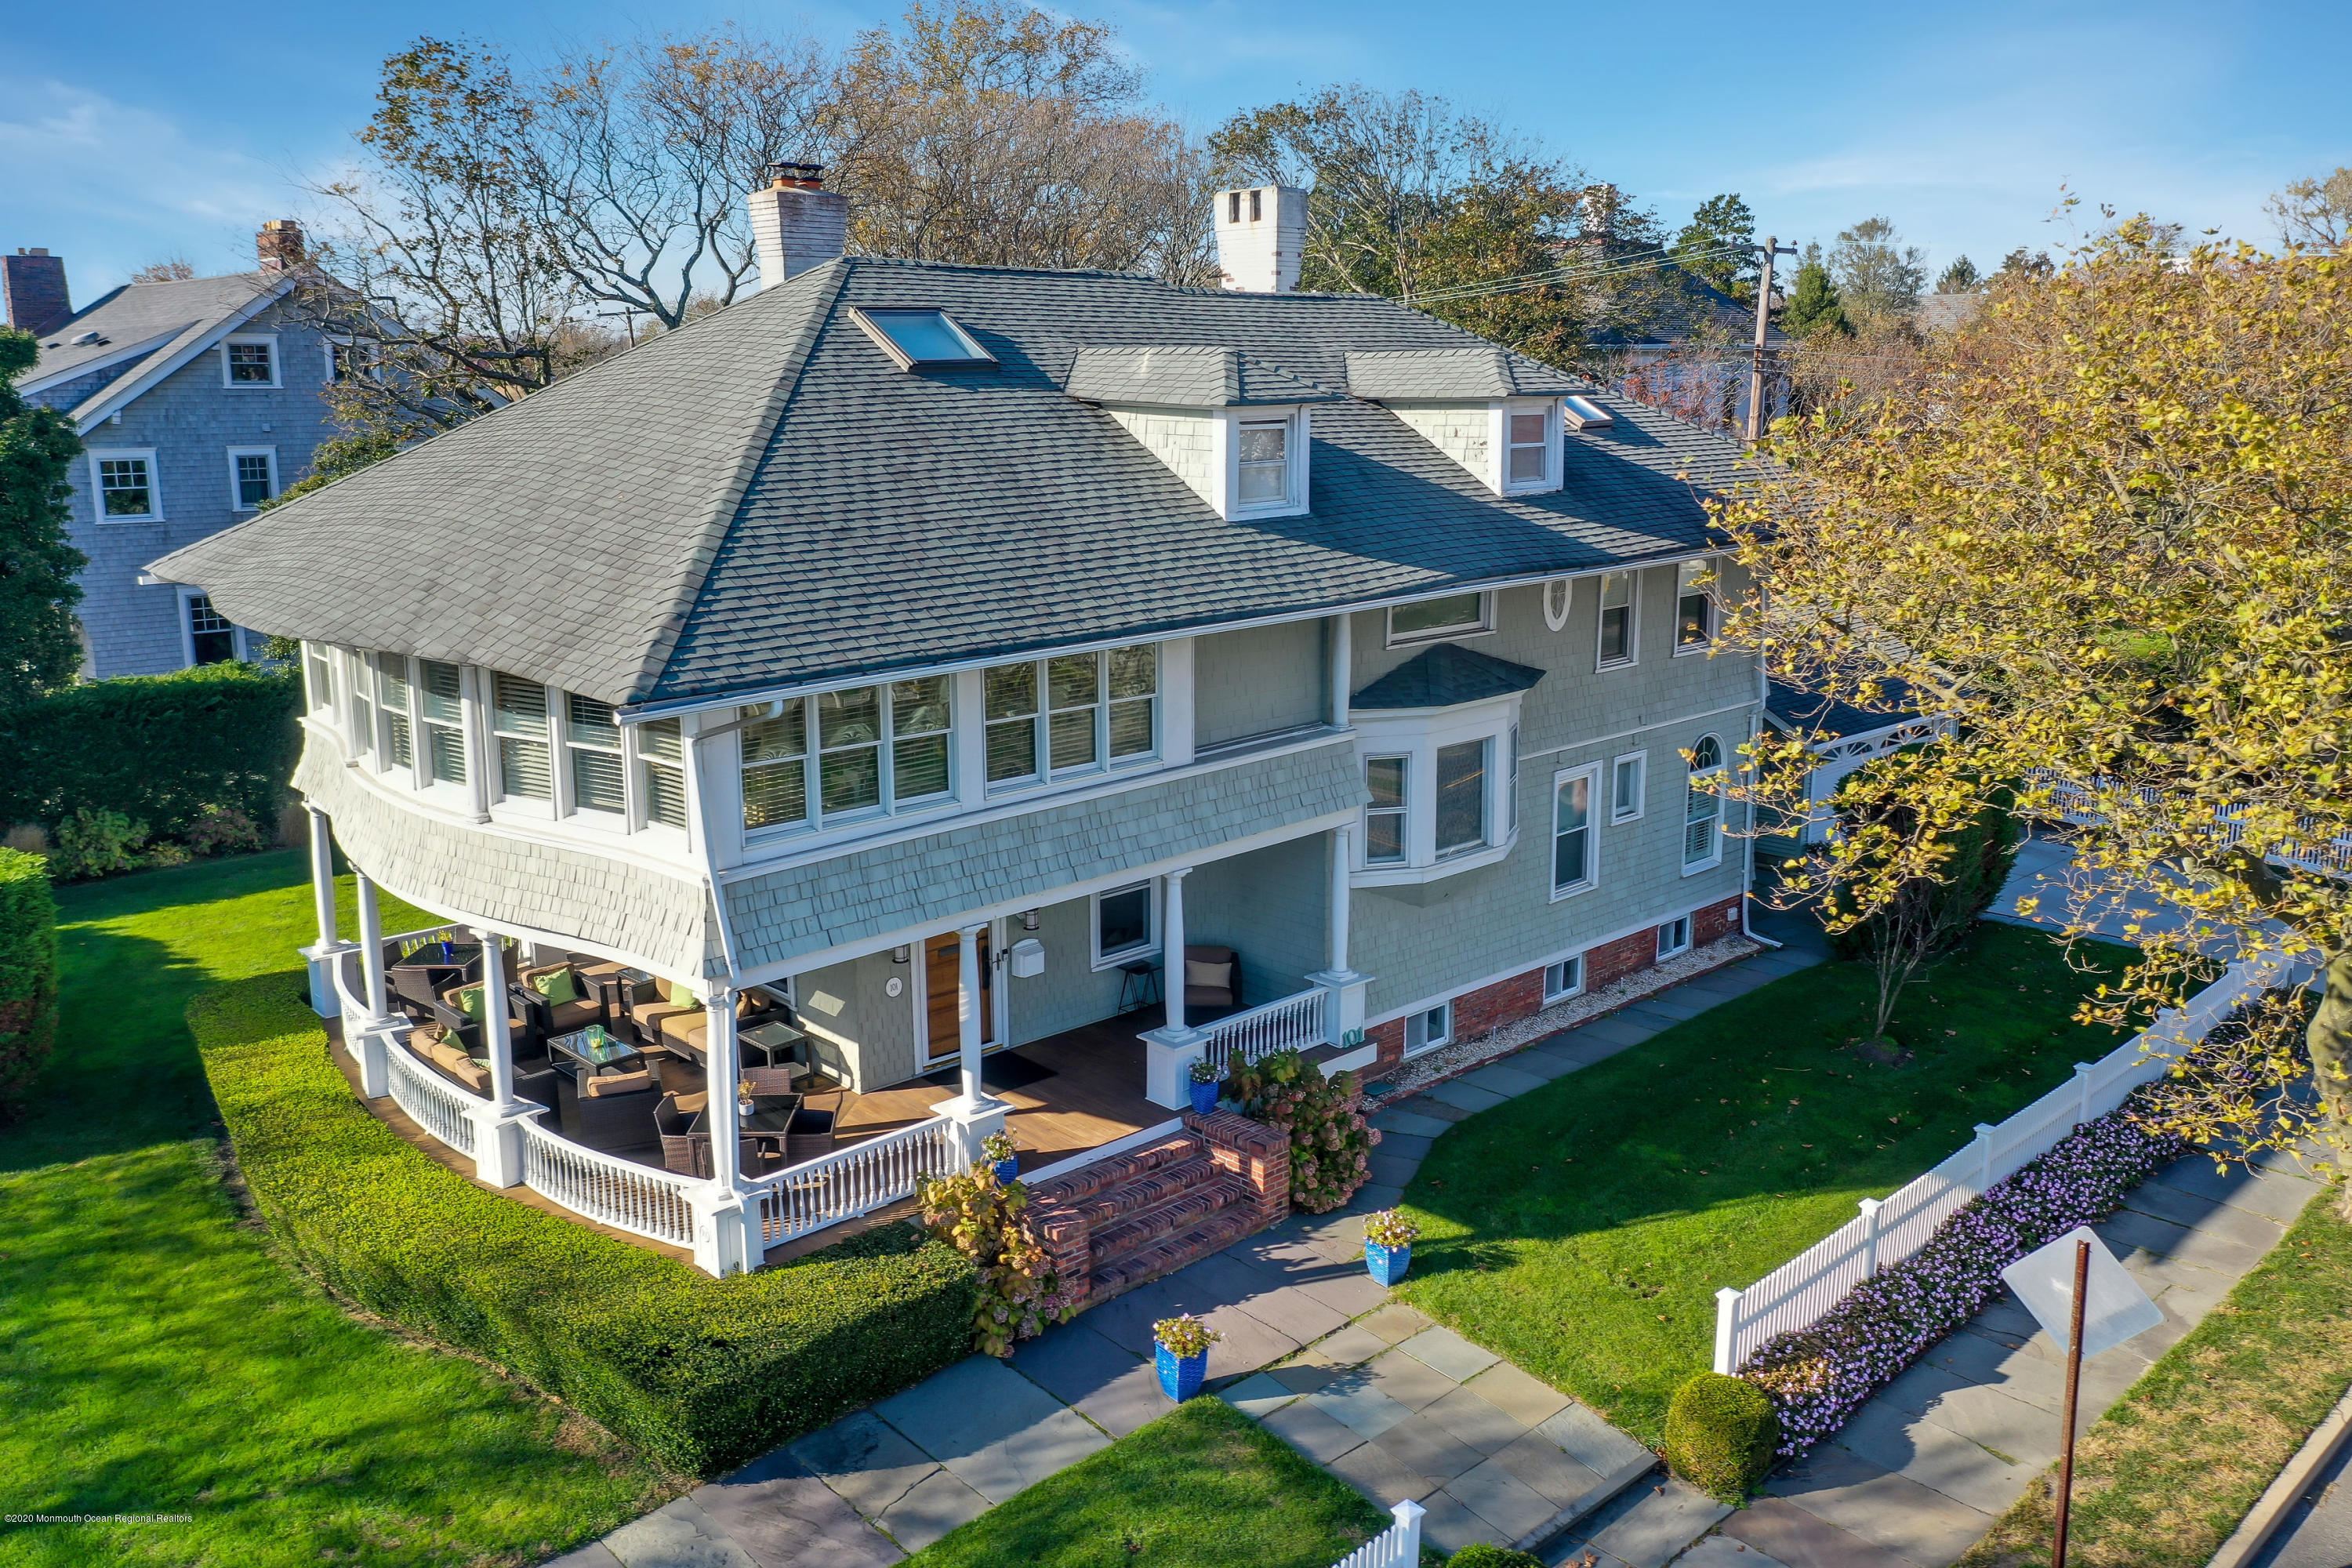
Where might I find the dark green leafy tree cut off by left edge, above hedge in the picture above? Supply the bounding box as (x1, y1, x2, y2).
(0, 327, 89, 708)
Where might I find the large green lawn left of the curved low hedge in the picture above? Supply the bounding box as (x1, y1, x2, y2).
(0, 853, 680, 1568)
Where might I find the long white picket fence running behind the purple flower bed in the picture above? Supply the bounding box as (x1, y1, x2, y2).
(1715, 956, 2310, 1373)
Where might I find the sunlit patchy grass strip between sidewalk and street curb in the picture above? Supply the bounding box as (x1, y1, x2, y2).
(1959, 1192, 2352, 1568)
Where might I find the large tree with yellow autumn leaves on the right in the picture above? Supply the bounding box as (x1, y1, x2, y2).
(1722, 221, 2352, 1203)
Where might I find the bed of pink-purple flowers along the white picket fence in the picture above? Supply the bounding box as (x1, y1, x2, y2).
(1738, 1091, 2187, 1457)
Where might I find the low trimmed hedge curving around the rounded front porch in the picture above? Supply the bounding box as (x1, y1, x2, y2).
(188, 973, 976, 1474)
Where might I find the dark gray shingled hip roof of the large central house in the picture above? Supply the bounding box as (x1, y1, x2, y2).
(153, 259, 1738, 703)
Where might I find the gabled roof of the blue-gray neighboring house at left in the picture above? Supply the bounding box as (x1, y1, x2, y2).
(16, 273, 294, 426)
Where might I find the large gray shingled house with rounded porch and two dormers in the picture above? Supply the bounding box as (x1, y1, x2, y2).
(153, 172, 1762, 1293)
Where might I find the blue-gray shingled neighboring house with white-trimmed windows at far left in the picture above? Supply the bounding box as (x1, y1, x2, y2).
(0, 219, 336, 680)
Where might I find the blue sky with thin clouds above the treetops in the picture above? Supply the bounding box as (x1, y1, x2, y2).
(0, 0, 2352, 301)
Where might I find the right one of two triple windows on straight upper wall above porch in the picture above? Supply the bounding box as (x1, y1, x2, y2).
(981, 642, 1160, 785)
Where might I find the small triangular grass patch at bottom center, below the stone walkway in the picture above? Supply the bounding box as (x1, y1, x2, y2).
(908, 1399, 1390, 1568)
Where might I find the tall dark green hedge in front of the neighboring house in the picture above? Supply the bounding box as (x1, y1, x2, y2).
(0, 663, 301, 839)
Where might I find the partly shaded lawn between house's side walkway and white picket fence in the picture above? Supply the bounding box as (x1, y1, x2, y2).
(1404, 924, 2129, 1443)
